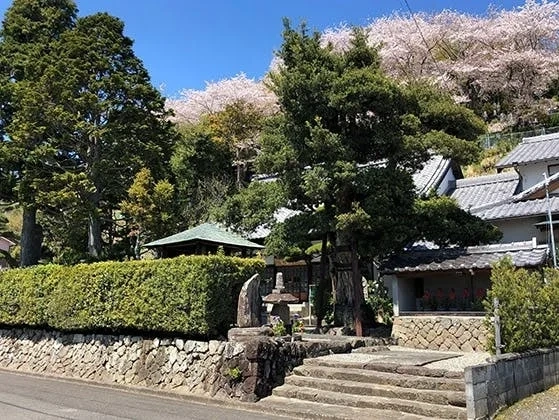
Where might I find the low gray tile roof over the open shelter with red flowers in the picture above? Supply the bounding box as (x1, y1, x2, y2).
(383, 241, 547, 274)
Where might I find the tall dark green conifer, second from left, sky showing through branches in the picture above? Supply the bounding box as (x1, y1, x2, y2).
(37, 13, 176, 259)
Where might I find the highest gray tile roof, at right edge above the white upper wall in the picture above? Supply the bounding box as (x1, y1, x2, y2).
(496, 133, 559, 169)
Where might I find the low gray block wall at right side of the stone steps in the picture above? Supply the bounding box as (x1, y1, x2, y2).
(464, 347, 559, 419)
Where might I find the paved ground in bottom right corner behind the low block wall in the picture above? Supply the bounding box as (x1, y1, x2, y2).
(497, 385, 559, 420)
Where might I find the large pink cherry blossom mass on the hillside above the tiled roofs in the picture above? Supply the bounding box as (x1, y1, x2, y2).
(322, 0, 559, 130)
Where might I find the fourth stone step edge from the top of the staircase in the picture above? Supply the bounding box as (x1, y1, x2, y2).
(272, 384, 466, 419)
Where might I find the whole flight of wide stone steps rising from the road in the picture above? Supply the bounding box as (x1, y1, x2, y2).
(258, 357, 466, 420)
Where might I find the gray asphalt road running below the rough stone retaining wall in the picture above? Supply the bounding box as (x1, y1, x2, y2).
(0, 371, 294, 420)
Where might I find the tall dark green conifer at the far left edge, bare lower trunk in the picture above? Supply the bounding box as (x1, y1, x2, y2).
(0, 0, 77, 266)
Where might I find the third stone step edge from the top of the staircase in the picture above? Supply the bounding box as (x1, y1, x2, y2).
(285, 375, 466, 407)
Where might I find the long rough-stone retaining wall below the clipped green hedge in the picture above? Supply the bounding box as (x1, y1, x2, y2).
(0, 329, 358, 401)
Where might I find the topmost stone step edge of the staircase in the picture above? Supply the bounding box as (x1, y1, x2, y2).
(303, 357, 464, 379)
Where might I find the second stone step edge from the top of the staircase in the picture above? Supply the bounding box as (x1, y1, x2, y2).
(292, 365, 466, 392)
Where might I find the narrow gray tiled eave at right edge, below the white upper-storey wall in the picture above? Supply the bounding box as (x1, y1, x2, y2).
(472, 196, 559, 220)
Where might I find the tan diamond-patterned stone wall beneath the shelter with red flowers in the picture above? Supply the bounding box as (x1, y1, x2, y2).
(392, 315, 487, 352)
